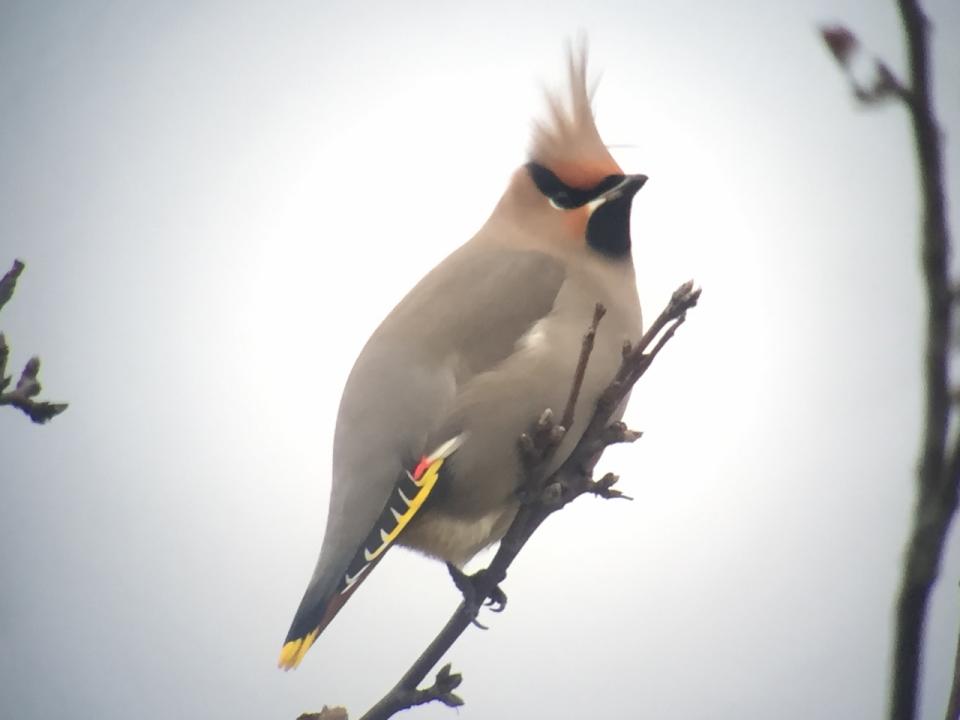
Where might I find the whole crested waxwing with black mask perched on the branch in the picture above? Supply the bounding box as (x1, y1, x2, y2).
(278, 43, 647, 670)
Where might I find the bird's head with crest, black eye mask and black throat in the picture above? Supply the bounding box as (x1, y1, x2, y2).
(488, 46, 647, 258)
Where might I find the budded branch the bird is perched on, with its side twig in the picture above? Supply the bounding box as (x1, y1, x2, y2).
(344, 282, 700, 720)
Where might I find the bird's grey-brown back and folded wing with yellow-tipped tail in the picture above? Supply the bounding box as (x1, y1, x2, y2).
(280, 243, 565, 669)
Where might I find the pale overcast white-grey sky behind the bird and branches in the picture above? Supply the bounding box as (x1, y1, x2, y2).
(0, 0, 960, 720)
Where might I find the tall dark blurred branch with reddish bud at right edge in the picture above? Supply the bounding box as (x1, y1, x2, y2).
(821, 0, 960, 720)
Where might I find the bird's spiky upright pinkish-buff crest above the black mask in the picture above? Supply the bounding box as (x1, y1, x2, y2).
(529, 41, 623, 188)
